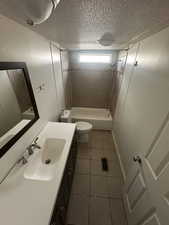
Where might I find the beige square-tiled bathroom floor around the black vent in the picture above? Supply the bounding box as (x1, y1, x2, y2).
(67, 131, 127, 225)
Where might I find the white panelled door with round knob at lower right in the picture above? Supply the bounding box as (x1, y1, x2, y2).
(123, 118, 169, 225)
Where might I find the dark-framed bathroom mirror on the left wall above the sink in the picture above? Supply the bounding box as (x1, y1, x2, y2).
(0, 62, 39, 158)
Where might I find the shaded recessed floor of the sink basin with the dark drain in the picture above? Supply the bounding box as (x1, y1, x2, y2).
(42, 138, 66, 164)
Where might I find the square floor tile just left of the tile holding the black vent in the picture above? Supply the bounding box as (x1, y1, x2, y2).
(75, 159, 90, 174)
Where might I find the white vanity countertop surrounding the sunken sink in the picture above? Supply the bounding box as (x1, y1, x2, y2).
(0, 122, 75, 225)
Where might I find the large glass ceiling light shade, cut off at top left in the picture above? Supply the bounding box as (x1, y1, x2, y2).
(26, 0, 60, 25)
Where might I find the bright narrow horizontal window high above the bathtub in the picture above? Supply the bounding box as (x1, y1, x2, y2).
(79, 53, 112, 64)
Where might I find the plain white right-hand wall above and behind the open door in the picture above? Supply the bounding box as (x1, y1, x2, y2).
(114, 25, 169, 176)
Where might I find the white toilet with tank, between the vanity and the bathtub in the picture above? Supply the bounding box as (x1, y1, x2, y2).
(60, 110, 93, 143)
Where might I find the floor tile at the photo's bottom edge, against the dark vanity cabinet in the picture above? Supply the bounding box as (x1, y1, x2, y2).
(67, 195, 89, 225)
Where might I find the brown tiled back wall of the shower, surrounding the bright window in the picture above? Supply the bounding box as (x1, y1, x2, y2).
(65, 51, 118, 108)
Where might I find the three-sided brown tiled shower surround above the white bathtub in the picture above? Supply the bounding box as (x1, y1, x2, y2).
(61, 50, 121, 116)
